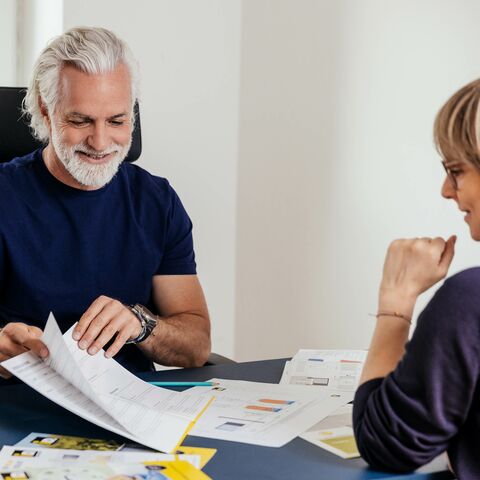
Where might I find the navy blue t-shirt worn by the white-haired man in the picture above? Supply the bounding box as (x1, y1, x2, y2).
(0, 150, 196, 371)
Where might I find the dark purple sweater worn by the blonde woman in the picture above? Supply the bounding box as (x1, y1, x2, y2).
(353, 268, 480, 480)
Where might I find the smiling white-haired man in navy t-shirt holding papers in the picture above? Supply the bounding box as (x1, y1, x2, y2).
(0, 28, 210, 376)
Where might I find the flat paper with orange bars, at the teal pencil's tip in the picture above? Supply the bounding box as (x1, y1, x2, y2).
(190, 378, 353, 447)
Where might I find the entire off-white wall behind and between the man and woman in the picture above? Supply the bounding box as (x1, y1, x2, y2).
(14, 0, 480, 360)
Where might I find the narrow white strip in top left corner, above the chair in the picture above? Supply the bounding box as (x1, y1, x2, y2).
(0, 0, 17, 87)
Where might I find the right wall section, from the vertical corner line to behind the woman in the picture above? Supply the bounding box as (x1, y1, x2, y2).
(236, 0, 480, 359)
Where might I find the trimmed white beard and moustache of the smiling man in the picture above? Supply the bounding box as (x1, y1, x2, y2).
(51, 125, 131, 188)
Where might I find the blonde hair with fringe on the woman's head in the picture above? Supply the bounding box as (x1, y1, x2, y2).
(434, 79, 480, 170)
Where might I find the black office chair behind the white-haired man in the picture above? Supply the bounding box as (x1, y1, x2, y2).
(0, 87, 235, 365)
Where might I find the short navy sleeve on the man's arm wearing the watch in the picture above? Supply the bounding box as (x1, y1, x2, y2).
(155, 186, 197, 275)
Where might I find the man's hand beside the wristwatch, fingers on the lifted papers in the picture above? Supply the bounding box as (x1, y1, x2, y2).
(73, 295, 142, 358)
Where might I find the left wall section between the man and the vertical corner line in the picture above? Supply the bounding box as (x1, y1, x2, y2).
(64, 0, 240, 356)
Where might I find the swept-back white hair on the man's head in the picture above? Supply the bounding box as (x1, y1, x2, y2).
(23, 27, 139, 143)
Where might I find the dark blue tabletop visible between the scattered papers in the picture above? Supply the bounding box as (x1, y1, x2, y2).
(0, 359, 453, 480)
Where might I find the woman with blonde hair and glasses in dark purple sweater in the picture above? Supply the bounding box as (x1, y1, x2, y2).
(353, 80, 480, 479)
